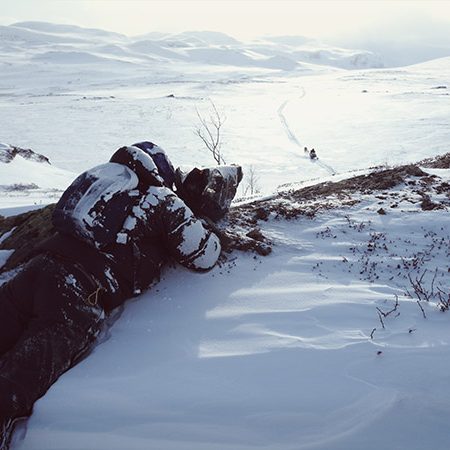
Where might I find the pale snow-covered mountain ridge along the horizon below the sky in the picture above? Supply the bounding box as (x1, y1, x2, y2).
(0, 22, 383, 71)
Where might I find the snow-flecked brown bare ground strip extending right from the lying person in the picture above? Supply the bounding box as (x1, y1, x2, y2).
(222, 153, 450, 255)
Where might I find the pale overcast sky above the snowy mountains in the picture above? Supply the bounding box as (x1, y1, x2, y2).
(0, 0, 450, 41)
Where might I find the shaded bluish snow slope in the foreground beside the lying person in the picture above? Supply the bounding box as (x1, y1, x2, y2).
(7, 165, 450, 450)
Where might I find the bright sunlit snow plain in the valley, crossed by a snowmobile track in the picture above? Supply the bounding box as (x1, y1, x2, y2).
(0, 59, 450, 201)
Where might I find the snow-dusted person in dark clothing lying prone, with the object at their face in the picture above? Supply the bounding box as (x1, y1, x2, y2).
(0, 142, 242, 450)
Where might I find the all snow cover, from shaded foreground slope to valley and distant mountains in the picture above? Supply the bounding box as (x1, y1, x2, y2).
(0, 23, 450, 450)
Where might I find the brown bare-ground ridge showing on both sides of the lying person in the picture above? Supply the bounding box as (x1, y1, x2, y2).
(0, 153, 450, 272)
